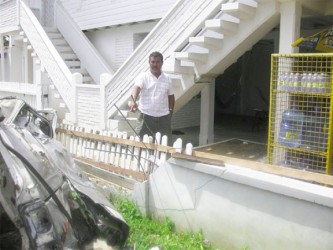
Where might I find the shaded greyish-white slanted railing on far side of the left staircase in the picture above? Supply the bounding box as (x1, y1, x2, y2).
(55, 1, 114, 83)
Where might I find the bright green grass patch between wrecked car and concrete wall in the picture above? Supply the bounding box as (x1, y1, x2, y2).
(112, 196, 217, 250)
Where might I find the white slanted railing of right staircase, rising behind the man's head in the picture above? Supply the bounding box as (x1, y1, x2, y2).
(106, 0, 222, 117)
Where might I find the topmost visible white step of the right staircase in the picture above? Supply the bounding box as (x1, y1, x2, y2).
(221, 2, 256, 19)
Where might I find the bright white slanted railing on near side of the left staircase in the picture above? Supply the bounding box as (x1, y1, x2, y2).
(20, 1, 75, 112)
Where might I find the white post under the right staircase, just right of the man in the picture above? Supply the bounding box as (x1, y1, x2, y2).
(199, 80, 215, 145)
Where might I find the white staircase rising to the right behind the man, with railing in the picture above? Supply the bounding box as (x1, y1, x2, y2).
(107, 0, 279, 133)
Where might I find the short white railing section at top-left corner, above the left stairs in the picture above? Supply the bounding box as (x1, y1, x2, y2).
(0, 1, 19, 33)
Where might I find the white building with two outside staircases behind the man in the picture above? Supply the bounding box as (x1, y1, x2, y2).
(0, 0, 333, 144)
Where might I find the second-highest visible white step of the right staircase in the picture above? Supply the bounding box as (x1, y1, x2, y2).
(205, 14, 239, 35)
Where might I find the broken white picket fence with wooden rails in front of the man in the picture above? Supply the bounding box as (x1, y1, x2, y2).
(55, 124, 189, 180)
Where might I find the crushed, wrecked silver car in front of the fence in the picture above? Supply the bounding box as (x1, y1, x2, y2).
(0, 98, 129, 249)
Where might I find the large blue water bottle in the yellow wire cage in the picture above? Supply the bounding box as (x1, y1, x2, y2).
(278, 105, 304, 148)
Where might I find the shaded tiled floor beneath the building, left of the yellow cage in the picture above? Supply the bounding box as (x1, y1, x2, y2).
(173, 116, 267, 162)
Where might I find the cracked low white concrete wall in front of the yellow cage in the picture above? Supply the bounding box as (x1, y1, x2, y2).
(133, 158, 333, 250)
